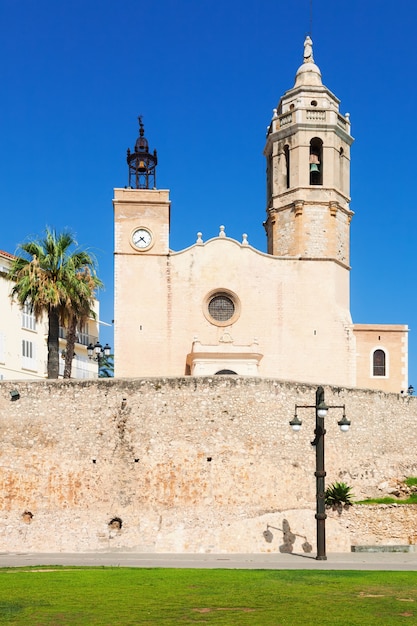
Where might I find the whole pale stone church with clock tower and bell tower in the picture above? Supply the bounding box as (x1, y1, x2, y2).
(113, 37, 408, 393)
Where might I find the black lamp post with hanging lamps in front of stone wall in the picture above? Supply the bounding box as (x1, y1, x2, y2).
(290, 387, 350, 561)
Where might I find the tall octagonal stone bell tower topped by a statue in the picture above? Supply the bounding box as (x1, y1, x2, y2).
(264, 37, 353, 269)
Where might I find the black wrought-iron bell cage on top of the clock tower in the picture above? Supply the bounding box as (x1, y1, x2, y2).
(126, 115, 158, 189)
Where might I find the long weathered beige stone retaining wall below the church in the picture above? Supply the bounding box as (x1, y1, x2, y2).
(0, 376, 417, 553)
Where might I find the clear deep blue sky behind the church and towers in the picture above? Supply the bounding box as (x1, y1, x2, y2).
(0, 0, 417, 388)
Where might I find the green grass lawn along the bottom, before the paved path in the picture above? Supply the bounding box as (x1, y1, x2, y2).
(0, 567, 417, 626)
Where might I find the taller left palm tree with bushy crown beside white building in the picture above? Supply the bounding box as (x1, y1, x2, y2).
(8, 228, 101, 378)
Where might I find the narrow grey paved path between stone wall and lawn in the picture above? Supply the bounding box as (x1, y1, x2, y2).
(0, 552, 417, 571)
